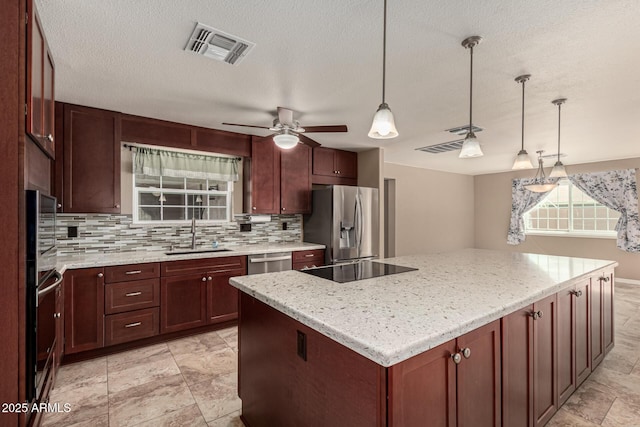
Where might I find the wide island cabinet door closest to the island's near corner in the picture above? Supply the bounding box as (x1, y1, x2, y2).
(388, 340, 457, 427)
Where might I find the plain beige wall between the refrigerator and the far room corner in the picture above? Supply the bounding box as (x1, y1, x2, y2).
(384, 163, 474, 256)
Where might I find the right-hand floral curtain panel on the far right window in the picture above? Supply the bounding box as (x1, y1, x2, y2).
(569, 169, 640, 252)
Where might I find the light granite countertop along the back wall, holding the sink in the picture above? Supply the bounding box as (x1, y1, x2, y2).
(56, 242, 325, 273)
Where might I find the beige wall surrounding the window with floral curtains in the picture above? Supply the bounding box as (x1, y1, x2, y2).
(475, 158, 640, 280)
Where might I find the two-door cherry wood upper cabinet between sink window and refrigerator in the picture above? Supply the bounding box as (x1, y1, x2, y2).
(245, 137, 311, 214)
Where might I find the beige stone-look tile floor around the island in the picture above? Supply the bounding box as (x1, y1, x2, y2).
(44, 284, 640, 427)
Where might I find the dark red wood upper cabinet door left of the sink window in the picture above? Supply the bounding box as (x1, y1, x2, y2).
(63, 104, 120, 213)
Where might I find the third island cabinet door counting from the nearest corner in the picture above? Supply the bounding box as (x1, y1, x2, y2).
(502, 305, 533, 427)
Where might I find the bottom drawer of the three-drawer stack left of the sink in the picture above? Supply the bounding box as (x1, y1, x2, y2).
(105, 307, 160, 345)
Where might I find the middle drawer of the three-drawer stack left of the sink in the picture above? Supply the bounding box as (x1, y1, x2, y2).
(104, 279, 160, 314)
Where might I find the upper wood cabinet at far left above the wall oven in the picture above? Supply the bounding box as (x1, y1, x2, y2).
(26, 1, 55, 158)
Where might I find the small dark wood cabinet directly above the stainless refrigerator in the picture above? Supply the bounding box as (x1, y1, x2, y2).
(312, 147, 358, 185)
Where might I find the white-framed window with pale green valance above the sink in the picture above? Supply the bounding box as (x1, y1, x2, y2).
(133, 147, 239, 223)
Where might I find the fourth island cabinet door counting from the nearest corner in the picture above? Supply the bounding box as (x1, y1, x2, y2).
(533, 294, 558, 426)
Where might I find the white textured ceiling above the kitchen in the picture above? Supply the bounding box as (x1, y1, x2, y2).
(37, 0, 640, 175)
